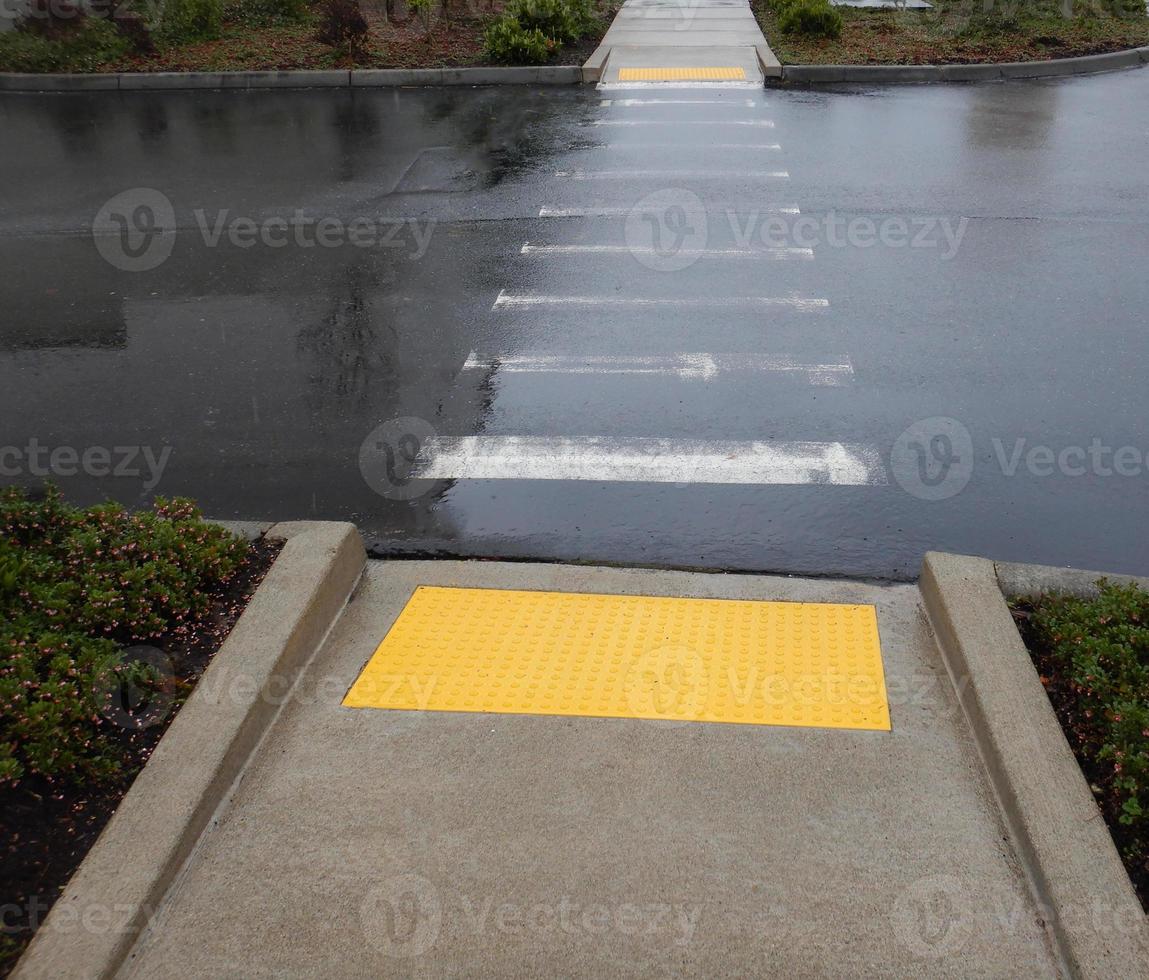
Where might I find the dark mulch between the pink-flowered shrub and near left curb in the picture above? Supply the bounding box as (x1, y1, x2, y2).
(0, 541, 282, 978)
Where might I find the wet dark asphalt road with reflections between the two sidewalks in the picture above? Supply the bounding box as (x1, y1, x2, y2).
(0, 71, 1149, 578)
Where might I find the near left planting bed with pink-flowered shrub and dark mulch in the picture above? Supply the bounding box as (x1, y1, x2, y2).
(0, 488, 279, 977)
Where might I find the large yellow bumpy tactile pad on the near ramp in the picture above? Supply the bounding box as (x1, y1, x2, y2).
(344, 586, 889, 731)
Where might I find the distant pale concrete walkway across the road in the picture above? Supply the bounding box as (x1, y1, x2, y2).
(583, 0, 781, 85)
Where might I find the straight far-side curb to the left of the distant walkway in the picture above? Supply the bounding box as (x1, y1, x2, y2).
(0, 64, 583, 92)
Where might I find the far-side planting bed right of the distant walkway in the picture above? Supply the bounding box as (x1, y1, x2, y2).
(751, 0, 1149, 64)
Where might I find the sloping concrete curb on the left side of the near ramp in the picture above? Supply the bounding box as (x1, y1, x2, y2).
(11, 522, 367, 980)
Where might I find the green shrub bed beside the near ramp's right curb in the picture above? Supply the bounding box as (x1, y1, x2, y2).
(1010, 580, 1149, 911)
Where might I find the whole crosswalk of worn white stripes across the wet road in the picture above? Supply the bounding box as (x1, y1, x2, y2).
(414, 87, 886, 486)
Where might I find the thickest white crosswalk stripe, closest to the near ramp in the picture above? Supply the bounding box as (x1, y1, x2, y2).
(412, 435, 886, 486)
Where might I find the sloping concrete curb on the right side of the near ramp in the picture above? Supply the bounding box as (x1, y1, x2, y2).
(919, 551, 1149, 978)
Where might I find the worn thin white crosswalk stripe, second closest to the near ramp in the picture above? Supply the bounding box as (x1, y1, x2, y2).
(463, 350, 854, 386)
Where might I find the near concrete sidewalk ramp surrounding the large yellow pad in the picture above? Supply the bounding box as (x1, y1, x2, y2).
(123, 562, 1057, 978)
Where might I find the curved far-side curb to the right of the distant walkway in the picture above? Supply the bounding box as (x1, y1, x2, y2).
(782, 47, 1149, 84)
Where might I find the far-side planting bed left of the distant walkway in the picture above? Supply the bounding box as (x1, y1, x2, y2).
(0, 0, 622, 72)
